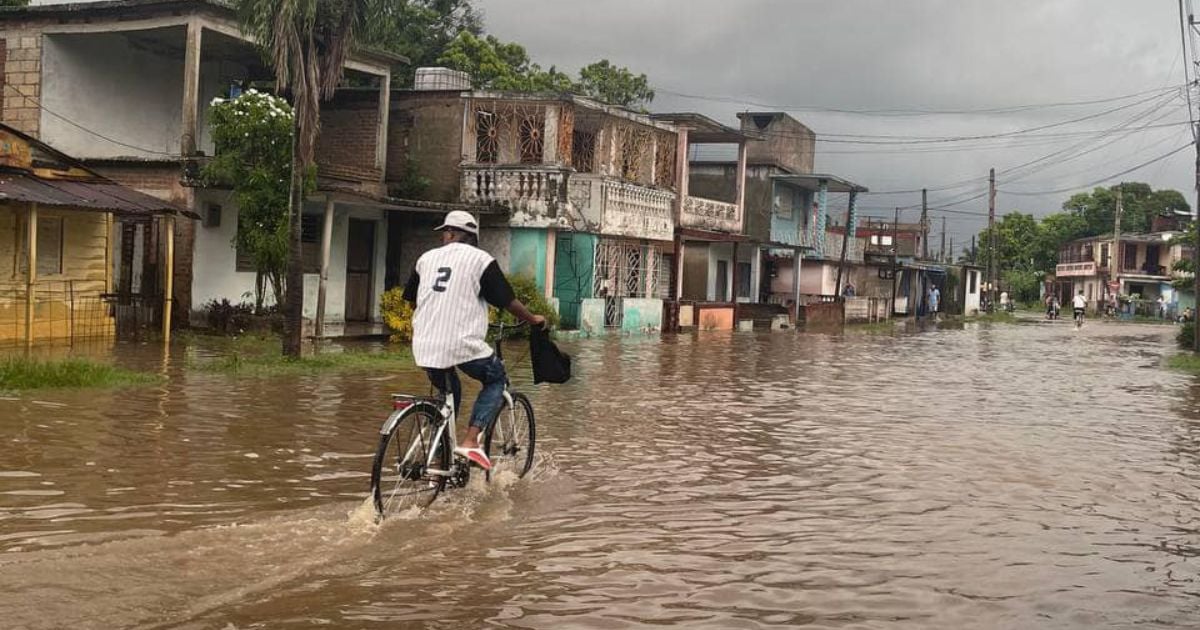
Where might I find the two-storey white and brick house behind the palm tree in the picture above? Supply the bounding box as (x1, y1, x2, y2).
(0, 0, 403, 336)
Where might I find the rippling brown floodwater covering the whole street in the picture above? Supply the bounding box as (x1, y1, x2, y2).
(0, 323, 1200, 630)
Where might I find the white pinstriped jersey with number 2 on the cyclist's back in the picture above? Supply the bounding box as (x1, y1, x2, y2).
(413, 242, 494, 368)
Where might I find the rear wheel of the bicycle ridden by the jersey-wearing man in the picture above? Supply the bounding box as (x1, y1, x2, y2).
(371, 407, 454, 518)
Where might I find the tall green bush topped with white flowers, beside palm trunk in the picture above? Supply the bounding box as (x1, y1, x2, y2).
(202, 90, 316, 311)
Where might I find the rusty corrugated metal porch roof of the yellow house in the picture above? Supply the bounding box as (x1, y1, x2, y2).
(0, 169, 189, 218)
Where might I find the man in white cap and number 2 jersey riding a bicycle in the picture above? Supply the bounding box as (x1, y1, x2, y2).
(404, 210, 546, 470)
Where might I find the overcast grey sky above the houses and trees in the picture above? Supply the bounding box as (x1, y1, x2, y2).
(478, 0, 1195, 249)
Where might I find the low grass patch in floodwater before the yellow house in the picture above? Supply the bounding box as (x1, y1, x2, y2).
(0, 358, 157, 391)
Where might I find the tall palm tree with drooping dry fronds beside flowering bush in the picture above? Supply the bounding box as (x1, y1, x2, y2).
(238, 0, 372, 356)
